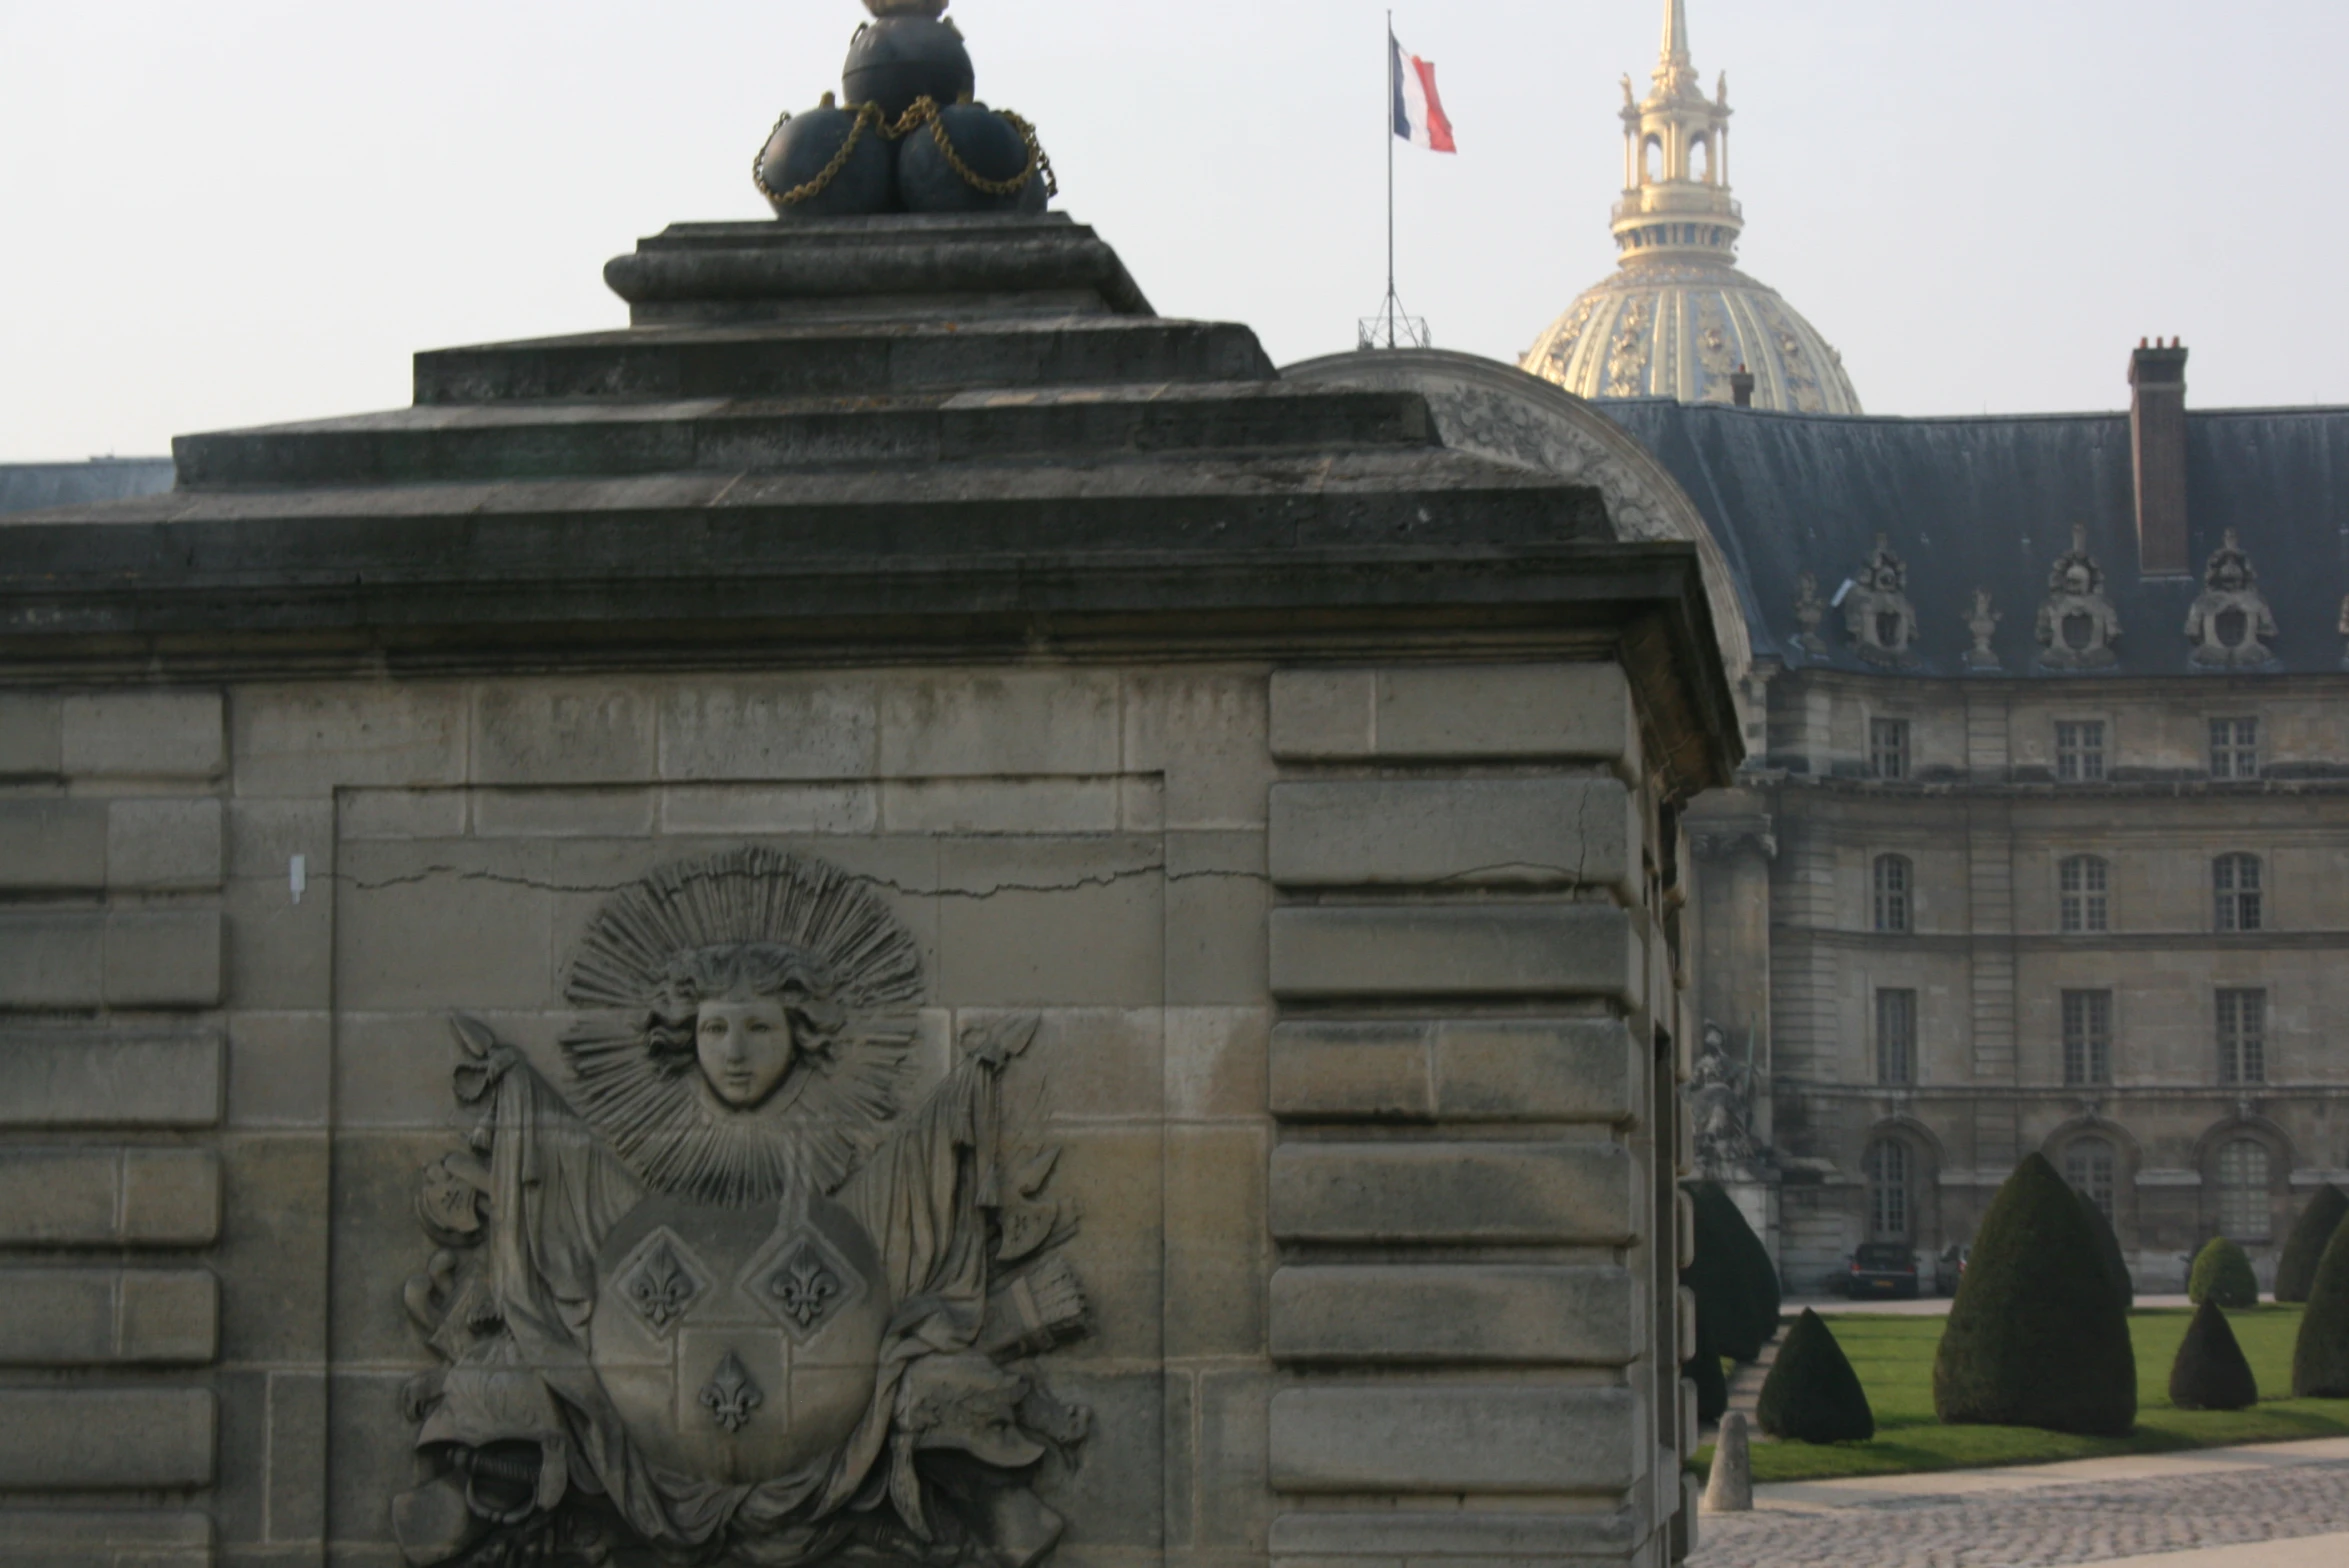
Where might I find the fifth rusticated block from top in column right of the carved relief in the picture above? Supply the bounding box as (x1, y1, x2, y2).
(1271, 1143, 1635, 1244)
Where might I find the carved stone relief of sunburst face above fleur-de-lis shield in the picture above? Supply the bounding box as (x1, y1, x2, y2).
(392, 850, 1090, 1568)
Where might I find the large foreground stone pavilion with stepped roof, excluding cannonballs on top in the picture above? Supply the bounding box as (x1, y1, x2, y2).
(0, 218, 1738, 1568)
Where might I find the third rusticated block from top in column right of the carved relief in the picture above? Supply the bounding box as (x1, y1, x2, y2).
(1271, 904, 1647, 1005)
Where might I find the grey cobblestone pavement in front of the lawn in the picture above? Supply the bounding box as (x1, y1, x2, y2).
(1689, 1462, 2349, 1568)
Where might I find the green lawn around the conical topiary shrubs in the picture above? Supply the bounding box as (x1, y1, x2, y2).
(1694, 1305, 2349, 1481)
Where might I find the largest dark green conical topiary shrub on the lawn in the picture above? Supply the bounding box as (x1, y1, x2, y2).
(1933, 1155, 2138, 1437)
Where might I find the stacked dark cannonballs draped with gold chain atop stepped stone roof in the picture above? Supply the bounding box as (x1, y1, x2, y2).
(752, 0, 1059, 218)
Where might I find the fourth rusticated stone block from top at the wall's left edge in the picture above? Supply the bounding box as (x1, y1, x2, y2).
(0, 1028, 221, 1127)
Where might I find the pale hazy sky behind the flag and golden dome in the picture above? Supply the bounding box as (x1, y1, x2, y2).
(0, 0, 2349, 462)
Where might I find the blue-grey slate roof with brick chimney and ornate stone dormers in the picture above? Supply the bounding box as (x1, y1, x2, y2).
(1595, 399, 2349, 678)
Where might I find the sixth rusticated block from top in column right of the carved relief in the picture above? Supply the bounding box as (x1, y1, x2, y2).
(1271, 1263, 1640, 1366)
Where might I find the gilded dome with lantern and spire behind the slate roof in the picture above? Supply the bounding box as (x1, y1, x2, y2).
(1520, 0, 1860, 413)
